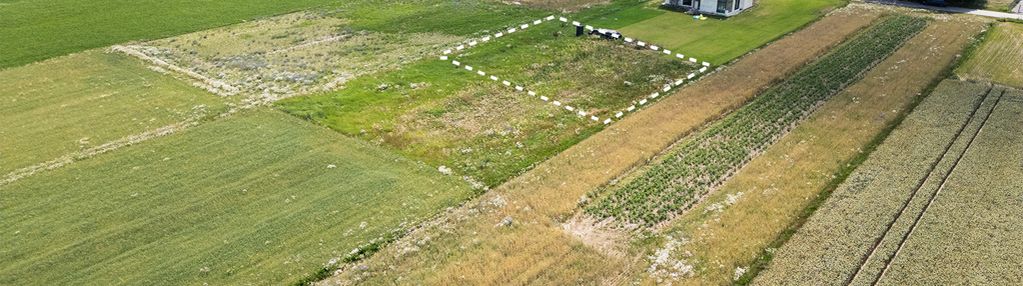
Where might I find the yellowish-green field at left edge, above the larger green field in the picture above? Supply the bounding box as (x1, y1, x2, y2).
(0, 50, 226, 176)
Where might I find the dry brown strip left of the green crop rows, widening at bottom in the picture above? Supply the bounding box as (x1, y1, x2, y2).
(323, 6, 878, 284)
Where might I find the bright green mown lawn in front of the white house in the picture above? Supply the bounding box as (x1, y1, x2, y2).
(620, 0, 846, 64)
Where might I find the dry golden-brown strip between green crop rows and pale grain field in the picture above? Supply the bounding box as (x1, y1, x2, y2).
(654, 16, 984, 285)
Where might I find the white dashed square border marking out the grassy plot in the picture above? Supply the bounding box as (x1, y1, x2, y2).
(440, 15, 710, 125)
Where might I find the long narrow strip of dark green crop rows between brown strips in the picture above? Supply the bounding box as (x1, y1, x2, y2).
(584, 15, 927, 227)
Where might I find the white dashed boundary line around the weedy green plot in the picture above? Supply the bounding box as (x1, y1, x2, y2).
(440, 15, 711, 125)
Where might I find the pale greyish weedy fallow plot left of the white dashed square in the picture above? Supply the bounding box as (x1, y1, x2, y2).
(129, 12, 458, 98)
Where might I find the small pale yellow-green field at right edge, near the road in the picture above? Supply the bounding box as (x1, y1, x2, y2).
(955, 22, 1023, 88)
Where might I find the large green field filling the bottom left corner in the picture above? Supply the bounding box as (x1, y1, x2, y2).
(0, 110, 472, 285)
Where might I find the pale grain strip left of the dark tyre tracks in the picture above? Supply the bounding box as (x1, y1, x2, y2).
(754, 81, 989, 285)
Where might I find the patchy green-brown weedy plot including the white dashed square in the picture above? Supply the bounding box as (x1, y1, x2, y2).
(278, 22, 697, 186)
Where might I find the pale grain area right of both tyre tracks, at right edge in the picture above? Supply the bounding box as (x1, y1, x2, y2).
(877, 90, 1023, 285)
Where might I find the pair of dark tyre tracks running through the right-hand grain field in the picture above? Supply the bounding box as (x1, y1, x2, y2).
(844, 88, 1000, 285)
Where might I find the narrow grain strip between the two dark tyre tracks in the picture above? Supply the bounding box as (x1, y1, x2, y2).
(847, 88, 1005, 285)
